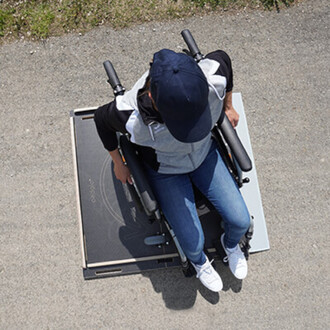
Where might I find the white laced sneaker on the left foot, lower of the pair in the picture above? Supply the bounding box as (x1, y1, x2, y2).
(191, 257, 223, 292)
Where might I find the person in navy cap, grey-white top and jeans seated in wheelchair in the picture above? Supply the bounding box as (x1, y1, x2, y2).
(95, 49, 250, 292)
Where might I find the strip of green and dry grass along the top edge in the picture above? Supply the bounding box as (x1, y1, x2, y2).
(0, 0, 301, 42)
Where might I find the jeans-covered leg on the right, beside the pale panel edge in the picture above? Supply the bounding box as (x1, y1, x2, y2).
(190, 143, 250, 248)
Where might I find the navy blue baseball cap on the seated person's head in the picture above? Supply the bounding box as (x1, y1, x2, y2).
(150, 49, 212, 143)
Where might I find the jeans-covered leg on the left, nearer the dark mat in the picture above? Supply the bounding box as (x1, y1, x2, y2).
(147, 168, 206, 265)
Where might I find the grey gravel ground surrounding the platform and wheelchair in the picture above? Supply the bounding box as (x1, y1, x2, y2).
(0, 0, 330, 329)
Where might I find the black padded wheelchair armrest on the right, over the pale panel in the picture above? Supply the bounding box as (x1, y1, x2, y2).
(219, 115, 252, 172)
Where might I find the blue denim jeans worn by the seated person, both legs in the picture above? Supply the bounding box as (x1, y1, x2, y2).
(147, 143, 250, 265)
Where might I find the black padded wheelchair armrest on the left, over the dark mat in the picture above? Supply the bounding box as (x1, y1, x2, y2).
(119, 135, 158, 216)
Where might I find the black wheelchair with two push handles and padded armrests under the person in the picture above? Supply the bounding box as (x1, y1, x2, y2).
(103, 30, 254, 277)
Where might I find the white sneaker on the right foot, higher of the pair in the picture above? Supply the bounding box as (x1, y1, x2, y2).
(221, 234, 247, 280)
